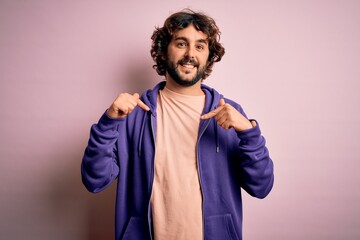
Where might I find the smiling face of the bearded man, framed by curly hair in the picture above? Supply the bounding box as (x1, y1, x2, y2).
(166, 25, 209, 86)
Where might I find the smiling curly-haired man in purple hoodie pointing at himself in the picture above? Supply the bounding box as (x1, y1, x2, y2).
(81, 10, 274, 240)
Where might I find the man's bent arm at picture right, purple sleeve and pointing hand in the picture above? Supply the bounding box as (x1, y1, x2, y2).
(201, 99, 274, 198)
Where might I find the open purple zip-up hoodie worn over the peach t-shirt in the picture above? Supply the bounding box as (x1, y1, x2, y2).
(81, 82, 274, 240)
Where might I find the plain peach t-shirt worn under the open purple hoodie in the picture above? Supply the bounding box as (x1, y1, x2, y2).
(151, 87, 205, 240)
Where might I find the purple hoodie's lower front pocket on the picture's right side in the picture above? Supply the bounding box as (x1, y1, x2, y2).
(205, 214, 239, 240)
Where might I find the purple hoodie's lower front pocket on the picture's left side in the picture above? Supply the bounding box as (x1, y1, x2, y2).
(122, 217, 148, 240)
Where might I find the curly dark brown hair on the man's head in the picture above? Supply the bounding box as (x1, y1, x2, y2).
(150, 9, 225, 80)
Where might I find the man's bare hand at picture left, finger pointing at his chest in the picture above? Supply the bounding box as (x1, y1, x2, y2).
(107, 93, 150, 118)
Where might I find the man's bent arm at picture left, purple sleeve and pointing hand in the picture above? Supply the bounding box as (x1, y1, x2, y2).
(81, 93, 149, 192)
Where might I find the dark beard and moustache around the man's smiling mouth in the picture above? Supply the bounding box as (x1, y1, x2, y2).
(166, 58, 205, 87)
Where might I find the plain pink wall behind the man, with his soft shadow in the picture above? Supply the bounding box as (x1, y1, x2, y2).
(0, 0, 360, 240)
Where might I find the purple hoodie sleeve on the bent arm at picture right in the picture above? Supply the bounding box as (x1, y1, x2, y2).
(237, 120, 274, 198)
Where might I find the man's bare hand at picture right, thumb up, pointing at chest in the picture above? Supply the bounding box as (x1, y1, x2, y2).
(201, 98, 253, 132)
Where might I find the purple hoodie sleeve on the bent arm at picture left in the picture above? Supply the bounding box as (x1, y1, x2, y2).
(81, 113, 125, 193)
